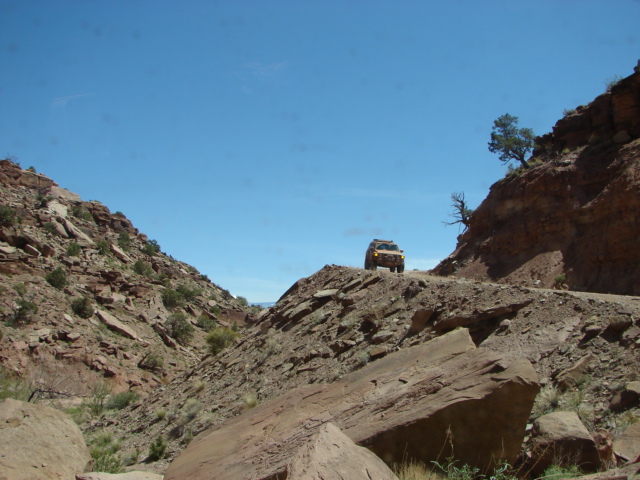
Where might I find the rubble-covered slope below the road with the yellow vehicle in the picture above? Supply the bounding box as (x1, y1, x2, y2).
(100, 266, 640, 478)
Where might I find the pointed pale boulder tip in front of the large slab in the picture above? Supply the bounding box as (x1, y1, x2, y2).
(287, 423, 398, 480)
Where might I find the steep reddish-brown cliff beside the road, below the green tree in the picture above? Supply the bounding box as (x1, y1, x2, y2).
(434, 68, 640, 295)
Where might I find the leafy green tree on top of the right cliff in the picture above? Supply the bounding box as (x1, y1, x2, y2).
(489, 113, 535, 169)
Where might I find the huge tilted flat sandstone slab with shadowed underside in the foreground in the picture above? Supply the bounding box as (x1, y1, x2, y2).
(165, 329, 538, 480)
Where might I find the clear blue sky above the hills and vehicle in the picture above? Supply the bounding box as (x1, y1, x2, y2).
(0, 0, 640, 302)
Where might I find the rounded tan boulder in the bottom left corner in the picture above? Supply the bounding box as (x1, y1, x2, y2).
(0, 399, 91, 480)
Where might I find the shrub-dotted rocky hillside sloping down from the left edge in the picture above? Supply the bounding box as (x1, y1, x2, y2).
(0, 160, 252, 399)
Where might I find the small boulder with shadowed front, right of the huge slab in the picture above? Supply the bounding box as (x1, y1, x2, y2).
(533, 412, 600, 474)
